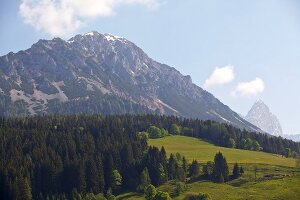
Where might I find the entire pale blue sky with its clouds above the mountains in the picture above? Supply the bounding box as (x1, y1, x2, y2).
(0, 0, 300, 134)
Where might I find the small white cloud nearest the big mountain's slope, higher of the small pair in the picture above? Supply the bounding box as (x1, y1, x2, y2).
(203, 65, 234, 88)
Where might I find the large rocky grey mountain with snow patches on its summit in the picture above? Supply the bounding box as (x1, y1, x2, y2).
(0, 32, 260, 131)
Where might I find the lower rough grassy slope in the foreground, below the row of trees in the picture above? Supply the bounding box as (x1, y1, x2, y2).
(118, 164, 300, 200)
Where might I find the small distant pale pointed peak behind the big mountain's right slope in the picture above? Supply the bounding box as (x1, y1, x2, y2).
(245, 100, 283, 136)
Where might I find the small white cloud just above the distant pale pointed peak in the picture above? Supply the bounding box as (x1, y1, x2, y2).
(231, 78, 265, 96)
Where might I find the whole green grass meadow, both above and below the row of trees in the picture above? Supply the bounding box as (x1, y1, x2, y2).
(118, 136, 300, 200)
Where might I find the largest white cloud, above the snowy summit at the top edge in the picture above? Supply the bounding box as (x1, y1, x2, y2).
(19, 0, 160, 36)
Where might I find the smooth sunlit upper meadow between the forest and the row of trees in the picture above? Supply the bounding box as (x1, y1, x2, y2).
(148, 136, 295, 167)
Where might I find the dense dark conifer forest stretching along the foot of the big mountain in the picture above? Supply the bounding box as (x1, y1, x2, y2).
(0, 115, 300, 199)
